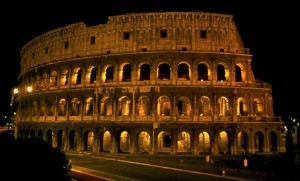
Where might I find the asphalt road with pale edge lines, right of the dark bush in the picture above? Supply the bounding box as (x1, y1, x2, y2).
(68, 155, 245, 181)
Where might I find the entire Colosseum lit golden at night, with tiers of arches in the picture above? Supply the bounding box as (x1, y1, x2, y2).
(14, 12, 285, 155)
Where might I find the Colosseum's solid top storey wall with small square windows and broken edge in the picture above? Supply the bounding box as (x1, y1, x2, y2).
(20, 12, 249, 72)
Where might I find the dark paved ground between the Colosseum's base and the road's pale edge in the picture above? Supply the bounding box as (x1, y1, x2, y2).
(66, 153, 300, 181)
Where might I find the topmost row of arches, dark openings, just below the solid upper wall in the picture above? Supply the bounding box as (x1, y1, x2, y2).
(20, 61, 247, 94)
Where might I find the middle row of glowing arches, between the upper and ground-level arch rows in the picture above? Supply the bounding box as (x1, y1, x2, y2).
(18, 95, 268, 117)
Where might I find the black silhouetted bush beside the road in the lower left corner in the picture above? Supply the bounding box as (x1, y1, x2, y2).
(0, 137, 71, 181)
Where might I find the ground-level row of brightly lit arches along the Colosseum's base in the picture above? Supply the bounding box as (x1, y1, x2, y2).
(18, 125, 281, 154)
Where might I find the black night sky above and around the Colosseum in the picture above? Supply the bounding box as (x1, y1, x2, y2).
(0, 0, 300, 117)
